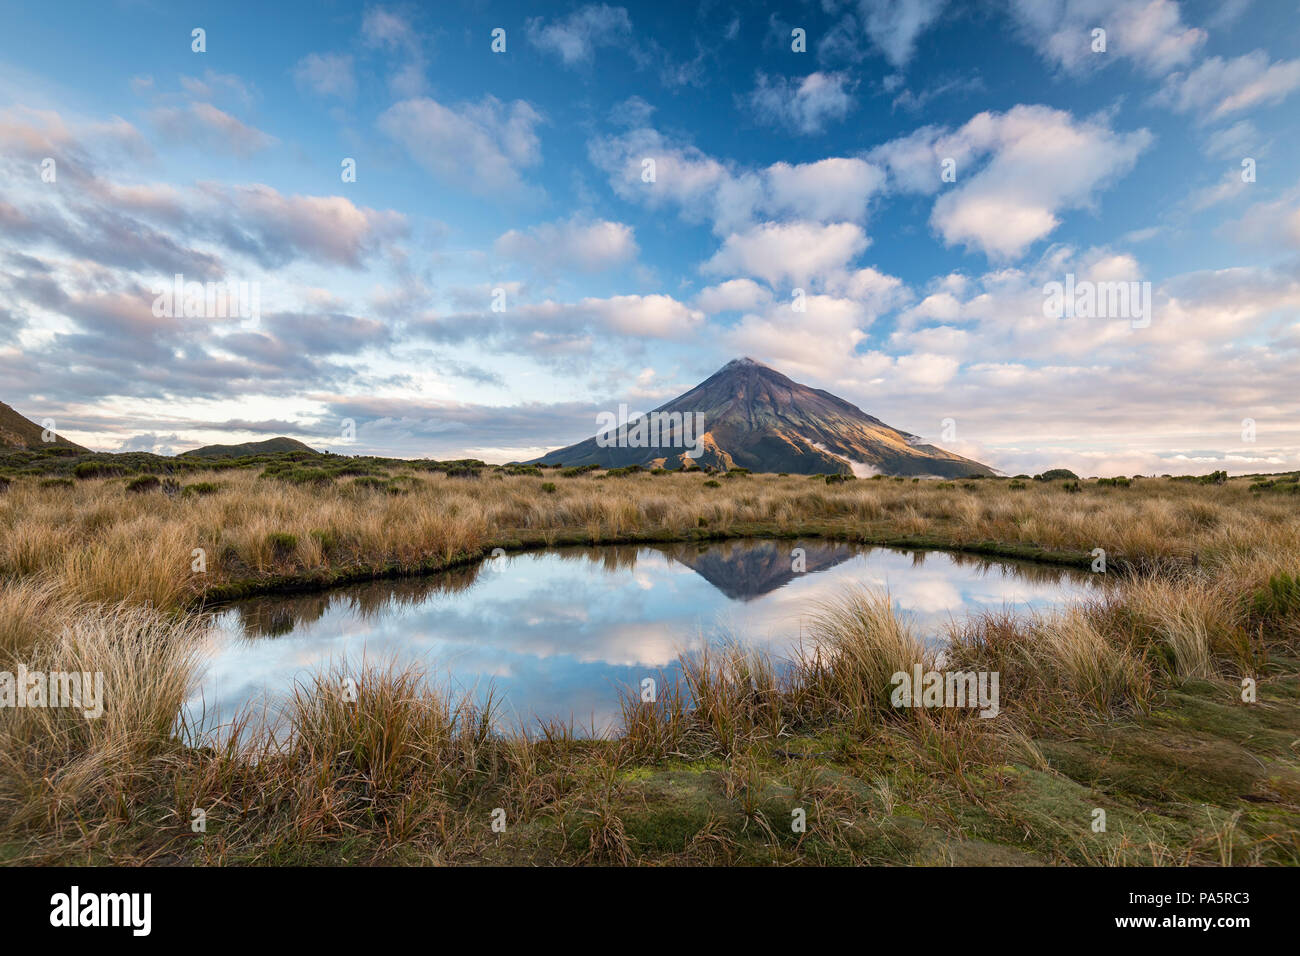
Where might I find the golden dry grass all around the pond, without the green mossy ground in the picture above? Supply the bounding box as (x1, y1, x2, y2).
(0, 471, 1300, 862)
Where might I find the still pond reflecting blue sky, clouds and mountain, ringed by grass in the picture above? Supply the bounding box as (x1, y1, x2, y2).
(187, 540, 1096, 732)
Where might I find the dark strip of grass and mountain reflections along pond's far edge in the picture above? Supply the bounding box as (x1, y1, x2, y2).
(215, 538, 1087, 637)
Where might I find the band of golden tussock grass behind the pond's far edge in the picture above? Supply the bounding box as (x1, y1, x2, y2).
(0, 466, 1300, 607)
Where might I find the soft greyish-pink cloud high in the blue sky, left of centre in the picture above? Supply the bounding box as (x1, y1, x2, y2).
(378, 96, 542, 196)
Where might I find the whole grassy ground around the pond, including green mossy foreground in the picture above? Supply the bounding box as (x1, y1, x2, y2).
(0, 468, 1300, 865)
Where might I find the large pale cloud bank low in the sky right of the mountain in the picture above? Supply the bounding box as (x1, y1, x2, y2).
(842, 254, 1300, 475)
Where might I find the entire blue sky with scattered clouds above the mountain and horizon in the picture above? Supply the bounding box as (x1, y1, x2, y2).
(0, 0, 1300, 473)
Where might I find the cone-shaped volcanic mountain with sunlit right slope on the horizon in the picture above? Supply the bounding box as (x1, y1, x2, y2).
(530, 358, 993, 477)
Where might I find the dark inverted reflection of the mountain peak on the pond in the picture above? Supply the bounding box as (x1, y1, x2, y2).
(657, 541, 863, 601)
